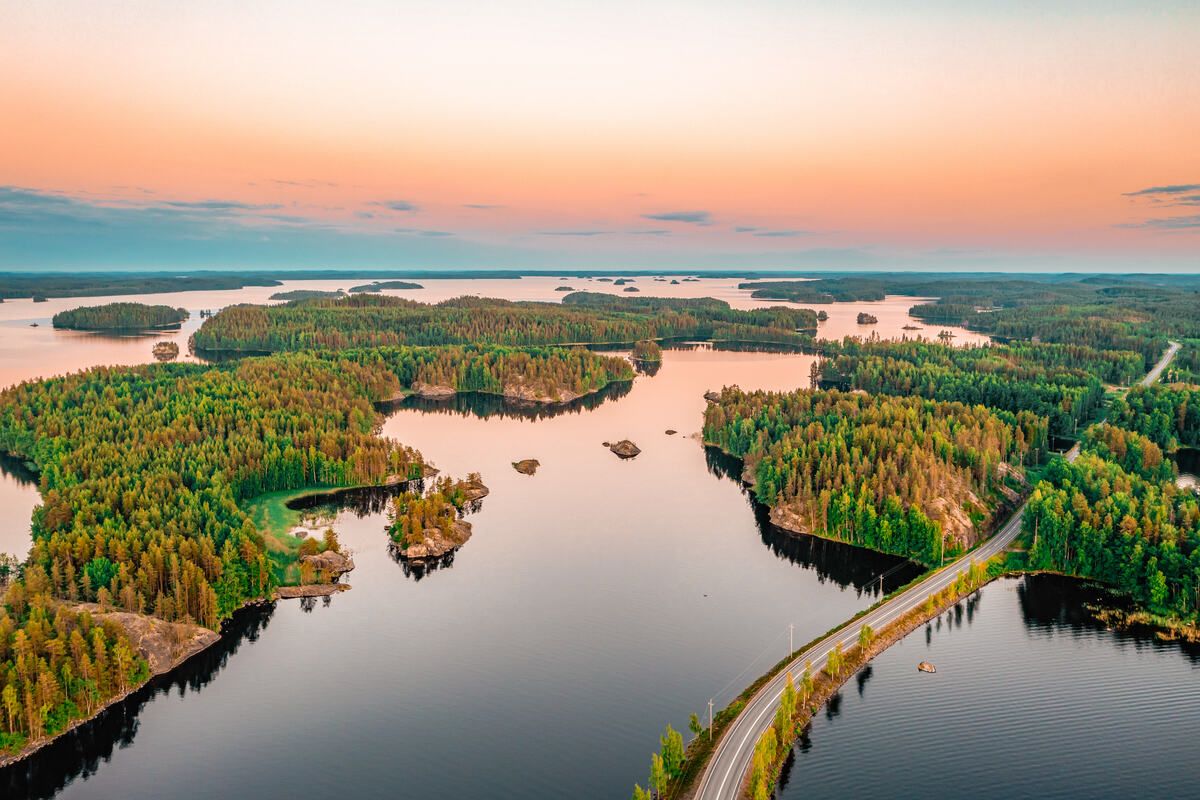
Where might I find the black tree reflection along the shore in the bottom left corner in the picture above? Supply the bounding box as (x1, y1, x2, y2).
(0, 606, 275, 800)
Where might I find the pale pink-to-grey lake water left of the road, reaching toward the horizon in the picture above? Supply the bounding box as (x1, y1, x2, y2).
(0, 278, 1177, 799)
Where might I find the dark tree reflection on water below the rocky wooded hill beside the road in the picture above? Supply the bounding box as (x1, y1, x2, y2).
(704, 447, 924, 596)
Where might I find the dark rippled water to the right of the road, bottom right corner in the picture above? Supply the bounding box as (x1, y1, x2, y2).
(778, 576, 1200, 800)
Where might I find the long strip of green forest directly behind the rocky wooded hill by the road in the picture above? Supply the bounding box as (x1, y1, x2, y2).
(818, 339, 1128, 438)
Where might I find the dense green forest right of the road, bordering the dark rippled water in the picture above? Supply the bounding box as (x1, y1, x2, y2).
(1022, 432, 1200, 621)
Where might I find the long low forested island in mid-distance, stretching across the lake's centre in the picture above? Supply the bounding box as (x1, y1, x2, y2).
(193, 293, 816, 351)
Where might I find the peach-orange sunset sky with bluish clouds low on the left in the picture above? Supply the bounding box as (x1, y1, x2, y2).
(0, 0, 1200, 271)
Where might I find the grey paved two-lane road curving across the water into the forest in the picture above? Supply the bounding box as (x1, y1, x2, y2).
(696, 342, 1180, 800)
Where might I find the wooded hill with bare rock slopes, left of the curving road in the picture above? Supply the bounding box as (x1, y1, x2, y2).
(703, 389, 1046, 564)
